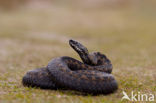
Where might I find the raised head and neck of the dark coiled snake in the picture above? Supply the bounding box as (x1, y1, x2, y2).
(69, 39, 90, 64)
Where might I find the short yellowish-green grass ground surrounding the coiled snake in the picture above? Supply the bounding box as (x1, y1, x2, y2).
(0, 2, 156, 103)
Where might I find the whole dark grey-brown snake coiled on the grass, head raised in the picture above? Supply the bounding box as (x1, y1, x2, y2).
(22, 40, 118, 94)
